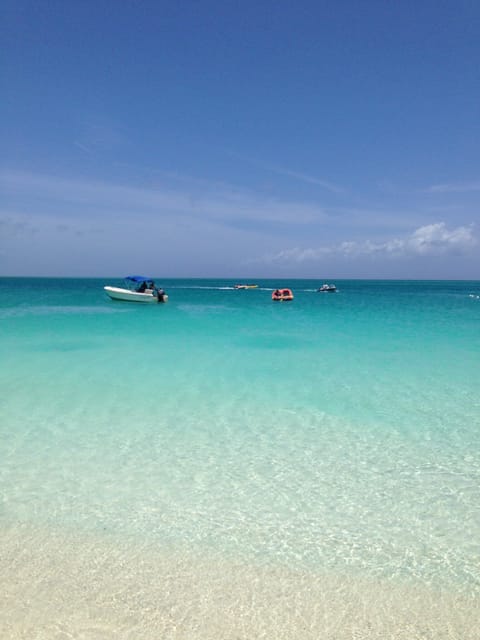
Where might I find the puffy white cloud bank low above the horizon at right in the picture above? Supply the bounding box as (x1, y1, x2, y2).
(261, 222, 478, 263)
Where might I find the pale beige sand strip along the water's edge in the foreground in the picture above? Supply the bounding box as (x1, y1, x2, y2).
(0, 526, 480, 640)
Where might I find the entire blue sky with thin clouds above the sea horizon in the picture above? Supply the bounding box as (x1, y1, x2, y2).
(0, 0, 480, 280)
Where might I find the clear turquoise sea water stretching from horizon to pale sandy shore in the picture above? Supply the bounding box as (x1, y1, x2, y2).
(0, 278, 480, 624)
